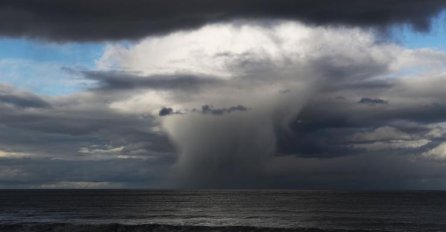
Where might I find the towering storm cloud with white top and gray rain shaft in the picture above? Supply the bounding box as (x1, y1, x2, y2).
(90, 22, 446, 187)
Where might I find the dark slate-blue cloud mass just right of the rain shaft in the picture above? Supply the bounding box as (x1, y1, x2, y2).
(277, 81, 446, 158)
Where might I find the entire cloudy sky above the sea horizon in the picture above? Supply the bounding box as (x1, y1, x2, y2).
(0, 0, 446, 190)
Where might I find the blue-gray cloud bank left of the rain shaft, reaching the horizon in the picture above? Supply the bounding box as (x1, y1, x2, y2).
(0, 84, 175, 188)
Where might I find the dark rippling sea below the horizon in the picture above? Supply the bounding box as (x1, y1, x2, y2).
(0, 190, 446, 232)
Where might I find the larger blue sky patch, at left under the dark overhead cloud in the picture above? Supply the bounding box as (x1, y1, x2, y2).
(0, 38, 104, 96)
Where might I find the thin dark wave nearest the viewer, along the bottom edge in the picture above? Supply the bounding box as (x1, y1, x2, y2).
(0, 223, 386, 232)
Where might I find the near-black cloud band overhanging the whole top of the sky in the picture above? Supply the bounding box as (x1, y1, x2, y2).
(0, 0, 446, 41)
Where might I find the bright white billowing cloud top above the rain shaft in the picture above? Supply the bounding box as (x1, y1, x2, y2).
(97, 22, 394, 78)
